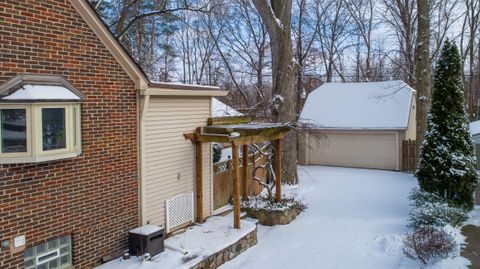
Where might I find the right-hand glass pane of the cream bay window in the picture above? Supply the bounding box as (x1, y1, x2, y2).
(42, 108, 66, 150)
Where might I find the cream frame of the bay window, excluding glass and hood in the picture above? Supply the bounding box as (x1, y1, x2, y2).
(0, 102, 82, 164)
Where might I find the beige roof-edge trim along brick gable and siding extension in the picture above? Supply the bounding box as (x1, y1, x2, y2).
(69, 0, 227, 96)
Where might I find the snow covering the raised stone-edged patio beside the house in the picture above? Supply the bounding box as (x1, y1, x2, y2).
(97, 213, 256, 269)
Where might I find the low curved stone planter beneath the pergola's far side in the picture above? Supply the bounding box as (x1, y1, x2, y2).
(244, 207, 301, 226)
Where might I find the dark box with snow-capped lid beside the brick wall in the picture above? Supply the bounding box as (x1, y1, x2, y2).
(128, 225, 165, 257)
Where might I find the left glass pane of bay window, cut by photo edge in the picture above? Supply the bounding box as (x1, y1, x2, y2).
(0, 109, 27, 153)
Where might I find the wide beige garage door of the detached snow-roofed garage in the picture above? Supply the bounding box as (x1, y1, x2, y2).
(309, 132, 399, 170)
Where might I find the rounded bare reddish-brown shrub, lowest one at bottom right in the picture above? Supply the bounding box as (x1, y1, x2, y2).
(403, 227, 456, 264)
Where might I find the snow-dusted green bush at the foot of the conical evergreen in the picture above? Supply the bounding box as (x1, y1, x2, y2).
(409, 189, 468, 228)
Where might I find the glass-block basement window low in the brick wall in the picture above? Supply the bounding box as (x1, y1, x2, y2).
(23, 235, 72, 269)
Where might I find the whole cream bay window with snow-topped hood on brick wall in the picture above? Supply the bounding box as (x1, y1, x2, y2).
(0, 76, 83, 164)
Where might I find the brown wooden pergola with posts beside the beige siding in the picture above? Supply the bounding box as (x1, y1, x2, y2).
(185, 117, 289, 229)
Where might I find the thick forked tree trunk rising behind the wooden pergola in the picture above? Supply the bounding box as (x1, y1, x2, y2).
(253, 0, 298, 184)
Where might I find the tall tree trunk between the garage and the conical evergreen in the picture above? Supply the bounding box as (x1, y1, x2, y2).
(415, 0, 431, 161)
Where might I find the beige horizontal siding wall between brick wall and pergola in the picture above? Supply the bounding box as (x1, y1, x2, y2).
(142, 96, 212, 227)
